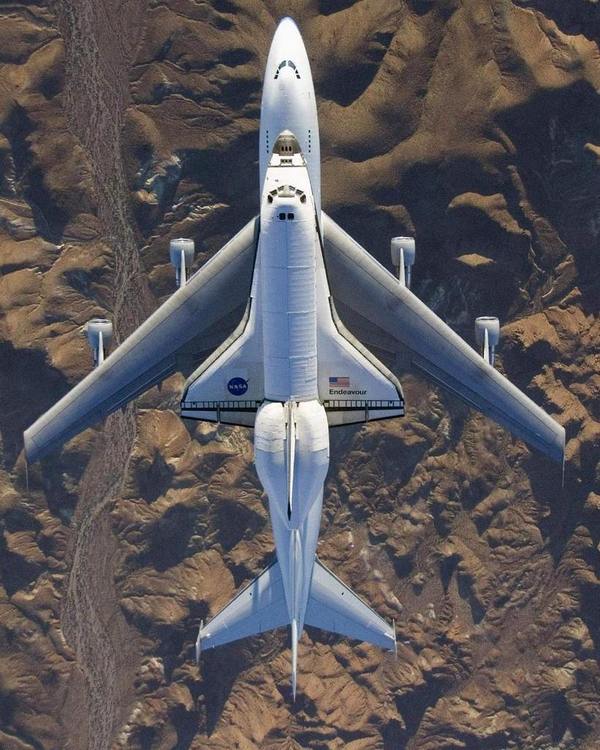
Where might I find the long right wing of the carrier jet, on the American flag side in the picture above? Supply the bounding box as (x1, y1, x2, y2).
(322, 213, 565, 462)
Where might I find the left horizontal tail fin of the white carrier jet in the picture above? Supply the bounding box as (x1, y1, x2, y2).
(196, 562, 290, 657)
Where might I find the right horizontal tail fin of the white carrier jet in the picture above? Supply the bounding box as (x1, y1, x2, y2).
(305, 560, 396, 651)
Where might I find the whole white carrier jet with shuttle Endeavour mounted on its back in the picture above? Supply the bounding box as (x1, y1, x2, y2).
(24, 18, 565, 695)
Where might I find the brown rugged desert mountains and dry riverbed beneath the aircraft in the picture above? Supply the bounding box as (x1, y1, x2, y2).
(0, 0, 600, 750)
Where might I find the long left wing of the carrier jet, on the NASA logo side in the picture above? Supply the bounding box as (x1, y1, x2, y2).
(24, 218, 259, 461)
